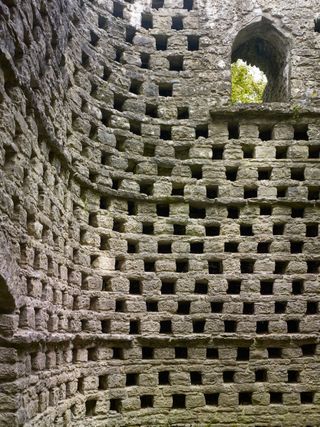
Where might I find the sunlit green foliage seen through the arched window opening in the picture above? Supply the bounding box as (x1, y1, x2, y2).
(231, 59, 267, 104)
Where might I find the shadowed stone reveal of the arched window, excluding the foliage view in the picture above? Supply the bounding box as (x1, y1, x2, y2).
(231, 18, 290, 102)
